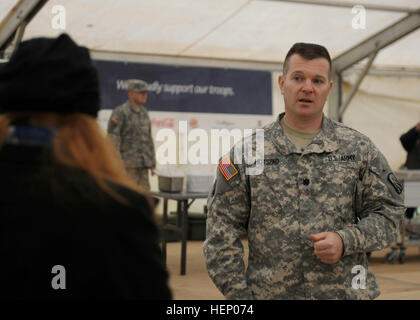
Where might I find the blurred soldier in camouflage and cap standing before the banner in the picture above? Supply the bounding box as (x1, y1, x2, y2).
(108, 79, 156, 189)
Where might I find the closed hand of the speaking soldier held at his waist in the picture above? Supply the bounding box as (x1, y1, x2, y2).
(310, 232, 343, 264)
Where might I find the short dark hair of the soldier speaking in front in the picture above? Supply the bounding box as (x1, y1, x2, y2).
(283, 42, 331, 78)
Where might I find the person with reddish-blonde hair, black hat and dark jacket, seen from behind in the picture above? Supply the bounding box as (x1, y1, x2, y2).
(0, 34, 172, 299)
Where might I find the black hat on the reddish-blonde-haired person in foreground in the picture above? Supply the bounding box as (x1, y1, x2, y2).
(0, 34, 100, 117)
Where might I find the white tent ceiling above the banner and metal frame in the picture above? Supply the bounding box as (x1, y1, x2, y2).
(0, 0, 420, 68)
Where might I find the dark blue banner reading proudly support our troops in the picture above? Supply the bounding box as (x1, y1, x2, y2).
(94, 60, 272, 115)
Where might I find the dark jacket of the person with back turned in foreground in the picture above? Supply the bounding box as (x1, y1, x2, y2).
(0, 144, 171, 299)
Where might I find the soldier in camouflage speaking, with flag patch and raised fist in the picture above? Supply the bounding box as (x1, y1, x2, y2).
(203, 43, 405, 299)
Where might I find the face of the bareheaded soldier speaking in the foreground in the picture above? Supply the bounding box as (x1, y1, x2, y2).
(279, 54, 333, 120)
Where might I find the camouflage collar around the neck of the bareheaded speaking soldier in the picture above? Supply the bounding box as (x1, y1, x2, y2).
(264, 112, 338, 155)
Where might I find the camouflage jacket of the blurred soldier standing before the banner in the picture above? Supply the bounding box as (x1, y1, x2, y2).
(108, 101, 156, 168)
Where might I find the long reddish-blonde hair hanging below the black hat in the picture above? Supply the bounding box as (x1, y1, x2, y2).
(0, 112, 154, 208)
